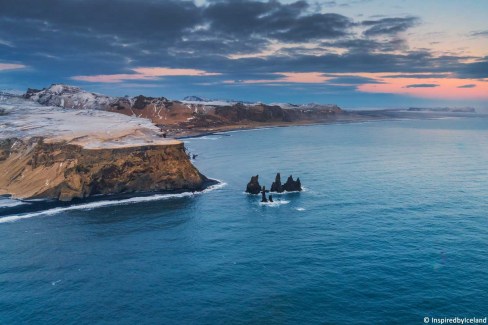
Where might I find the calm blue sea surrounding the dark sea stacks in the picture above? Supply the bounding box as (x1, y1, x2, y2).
(0, 118, 488, 324)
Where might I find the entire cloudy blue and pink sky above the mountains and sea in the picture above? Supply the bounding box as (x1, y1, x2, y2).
(0, 0, 488, 110)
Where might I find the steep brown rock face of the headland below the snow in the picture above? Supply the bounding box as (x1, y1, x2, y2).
(0, 138, 208, 201)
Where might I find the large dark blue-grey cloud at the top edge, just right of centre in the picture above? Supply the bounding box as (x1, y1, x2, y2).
(202, 0, 353, 42)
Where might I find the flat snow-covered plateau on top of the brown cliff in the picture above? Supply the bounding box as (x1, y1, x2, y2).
(0, 91, 176, 148)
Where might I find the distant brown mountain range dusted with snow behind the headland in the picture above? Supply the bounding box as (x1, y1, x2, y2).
(23, 84, 343, 134)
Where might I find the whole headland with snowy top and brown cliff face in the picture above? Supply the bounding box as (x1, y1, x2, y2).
(0, 94, 210, 201)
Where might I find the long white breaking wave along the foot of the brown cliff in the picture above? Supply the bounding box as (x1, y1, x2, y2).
(0, 181, 227, 223)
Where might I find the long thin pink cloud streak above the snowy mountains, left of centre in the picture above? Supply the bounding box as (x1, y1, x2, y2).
(71, 67, 220, 83)
